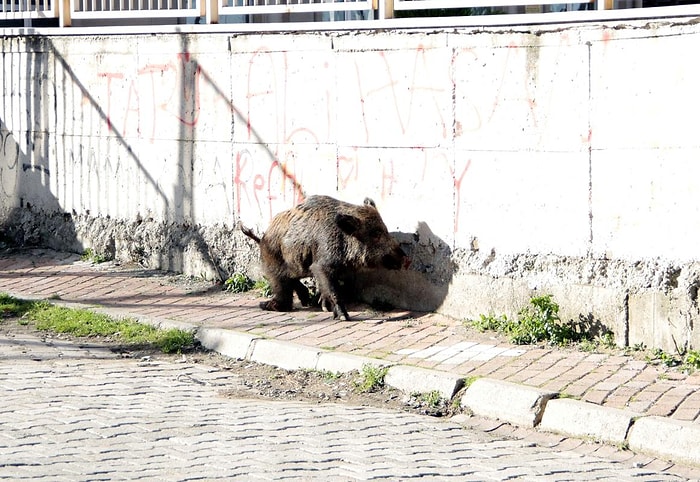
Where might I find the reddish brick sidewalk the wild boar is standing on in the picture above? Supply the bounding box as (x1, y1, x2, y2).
(0, 250, 700, 423)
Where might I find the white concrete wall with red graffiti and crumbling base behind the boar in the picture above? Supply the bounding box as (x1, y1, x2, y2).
(0, 20, 700, 349)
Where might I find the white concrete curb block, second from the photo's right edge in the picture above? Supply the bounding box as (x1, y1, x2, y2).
(539, 398, 639, 444)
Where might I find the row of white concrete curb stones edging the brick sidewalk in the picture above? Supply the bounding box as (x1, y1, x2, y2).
(189, 324, 700, 466)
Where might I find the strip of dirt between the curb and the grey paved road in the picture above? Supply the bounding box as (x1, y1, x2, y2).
(0, 318, 462, 417)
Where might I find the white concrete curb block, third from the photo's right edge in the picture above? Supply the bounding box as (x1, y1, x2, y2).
(461, 378, 558, 428)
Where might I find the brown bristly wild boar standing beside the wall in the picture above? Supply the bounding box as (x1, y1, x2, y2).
(241, 196, 409, 321)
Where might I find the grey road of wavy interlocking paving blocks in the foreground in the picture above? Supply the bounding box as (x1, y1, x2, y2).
(0, 335, 683, 481)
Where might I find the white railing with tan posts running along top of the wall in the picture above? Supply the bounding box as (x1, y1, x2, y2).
(0, 0, 700, 29)
